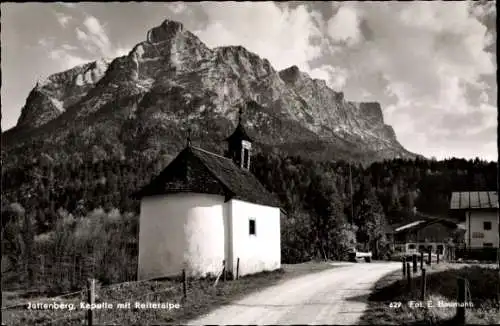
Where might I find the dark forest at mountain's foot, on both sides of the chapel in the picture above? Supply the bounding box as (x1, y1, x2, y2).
(1, 153, 497, 288)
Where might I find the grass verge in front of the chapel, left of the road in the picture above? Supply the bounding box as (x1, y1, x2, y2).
(2, 262, 335, 325)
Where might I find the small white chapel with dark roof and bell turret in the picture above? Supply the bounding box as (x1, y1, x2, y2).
(136, 109, 281, 280)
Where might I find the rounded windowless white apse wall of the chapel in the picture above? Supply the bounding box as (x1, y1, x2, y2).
(138, 193, 229, 280)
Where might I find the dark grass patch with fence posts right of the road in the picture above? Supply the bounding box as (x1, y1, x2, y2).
(361, 264, 500, 326)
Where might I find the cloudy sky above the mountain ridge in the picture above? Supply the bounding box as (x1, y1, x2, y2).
(1, 1, 498, 161)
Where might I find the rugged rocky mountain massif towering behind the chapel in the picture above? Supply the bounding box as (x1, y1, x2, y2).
(2, 20, 415, 166)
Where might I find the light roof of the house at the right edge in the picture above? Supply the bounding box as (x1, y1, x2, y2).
(450, 191, 498, 209)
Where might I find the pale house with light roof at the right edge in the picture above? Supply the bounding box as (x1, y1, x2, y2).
(450, 191, 500, 249)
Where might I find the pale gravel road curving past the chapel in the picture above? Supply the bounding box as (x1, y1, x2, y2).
(188, 262, 401, 325)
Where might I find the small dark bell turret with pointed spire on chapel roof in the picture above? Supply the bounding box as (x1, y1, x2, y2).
(225, 107, 253, 170)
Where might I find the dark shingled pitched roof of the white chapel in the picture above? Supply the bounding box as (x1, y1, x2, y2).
(134, 146, 279, 207)
